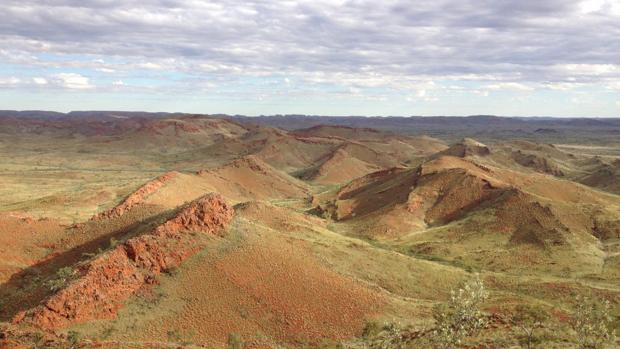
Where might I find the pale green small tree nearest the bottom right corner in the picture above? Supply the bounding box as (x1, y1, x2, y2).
(571, 296, 616, 349)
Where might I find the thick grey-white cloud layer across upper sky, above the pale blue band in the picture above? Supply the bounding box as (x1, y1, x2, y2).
(0, 0, 620, 87)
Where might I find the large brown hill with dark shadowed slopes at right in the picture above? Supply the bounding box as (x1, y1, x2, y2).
(314, 141, 620, 274)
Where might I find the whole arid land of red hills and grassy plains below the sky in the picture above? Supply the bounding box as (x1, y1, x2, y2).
(0, 112, 620, 348)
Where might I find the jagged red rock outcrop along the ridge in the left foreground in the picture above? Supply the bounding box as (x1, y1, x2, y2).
(21, 194, 234, 329)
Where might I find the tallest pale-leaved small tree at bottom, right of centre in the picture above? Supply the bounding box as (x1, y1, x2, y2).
(433, 274, 488, 349)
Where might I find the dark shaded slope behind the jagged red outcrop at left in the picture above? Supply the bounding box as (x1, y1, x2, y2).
(0, 205, 177, 321)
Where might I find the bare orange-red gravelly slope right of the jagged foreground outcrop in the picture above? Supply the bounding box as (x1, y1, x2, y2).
(154, 234, 384, 347)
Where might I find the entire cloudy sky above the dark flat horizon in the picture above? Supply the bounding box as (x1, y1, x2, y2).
(0, 0, 620, 117)
